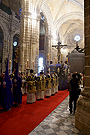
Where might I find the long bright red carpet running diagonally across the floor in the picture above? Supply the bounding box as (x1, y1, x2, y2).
(0, 90, 69, 135)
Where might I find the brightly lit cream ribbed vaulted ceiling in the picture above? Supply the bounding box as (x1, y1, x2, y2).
(41, 0, 84, 42)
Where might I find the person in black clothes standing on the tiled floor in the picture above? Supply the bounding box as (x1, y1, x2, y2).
(69, 73, 79, 114)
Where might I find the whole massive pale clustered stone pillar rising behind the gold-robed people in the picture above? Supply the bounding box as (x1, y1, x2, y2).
(19, 0, 39, 72)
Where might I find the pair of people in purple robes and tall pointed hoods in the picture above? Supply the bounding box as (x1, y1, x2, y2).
(0, 58, 22, 111)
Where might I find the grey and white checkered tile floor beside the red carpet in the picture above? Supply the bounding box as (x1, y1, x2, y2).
(29, 89, 83, 135)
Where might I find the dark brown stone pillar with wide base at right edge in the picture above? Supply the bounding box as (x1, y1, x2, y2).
(75, 0, 90, 135)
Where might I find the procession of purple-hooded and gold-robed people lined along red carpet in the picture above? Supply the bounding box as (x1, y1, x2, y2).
(0, 58, 58, 111)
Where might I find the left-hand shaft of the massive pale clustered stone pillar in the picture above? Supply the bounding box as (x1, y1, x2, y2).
(19, 0, 31, 72)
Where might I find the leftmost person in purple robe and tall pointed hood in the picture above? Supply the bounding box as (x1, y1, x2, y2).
(1, 56, 13, 111)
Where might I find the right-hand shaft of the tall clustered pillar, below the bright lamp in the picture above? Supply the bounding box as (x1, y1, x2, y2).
(31, 13, 40, 73)
